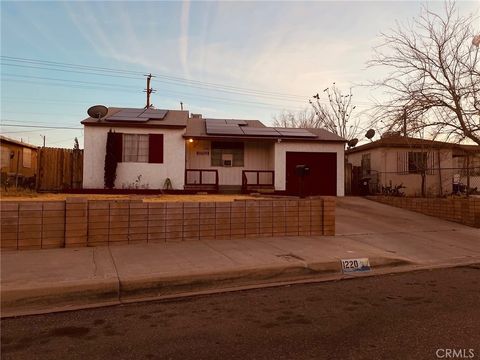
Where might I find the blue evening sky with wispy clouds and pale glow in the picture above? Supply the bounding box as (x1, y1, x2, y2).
(0, 1, 480, 148)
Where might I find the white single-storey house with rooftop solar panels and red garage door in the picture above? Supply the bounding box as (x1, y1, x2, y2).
(82, 108, 345, 196)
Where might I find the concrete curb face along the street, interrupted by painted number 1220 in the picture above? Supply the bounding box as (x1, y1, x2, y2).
(1, 257, 412, 318)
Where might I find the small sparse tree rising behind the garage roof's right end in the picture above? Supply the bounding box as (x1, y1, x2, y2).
(309, 83, 359, 140)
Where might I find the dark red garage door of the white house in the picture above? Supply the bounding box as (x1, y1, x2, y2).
(286, 152, 337, 196)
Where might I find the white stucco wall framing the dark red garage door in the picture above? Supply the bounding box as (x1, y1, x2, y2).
(275, 141, 345, 196)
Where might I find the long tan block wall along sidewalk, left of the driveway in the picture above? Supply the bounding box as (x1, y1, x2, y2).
(1, 197, 335, 250)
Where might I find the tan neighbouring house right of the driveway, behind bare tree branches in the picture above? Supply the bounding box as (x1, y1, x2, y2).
(346, 136, 480, 196)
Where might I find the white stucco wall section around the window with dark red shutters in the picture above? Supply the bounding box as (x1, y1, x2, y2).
(83, 126, 185, 189)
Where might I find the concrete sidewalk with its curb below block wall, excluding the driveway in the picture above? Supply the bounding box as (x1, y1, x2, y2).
(1, 236, 407, 316)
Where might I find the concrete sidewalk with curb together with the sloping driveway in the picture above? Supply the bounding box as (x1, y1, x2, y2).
(1, 198, 480, 317)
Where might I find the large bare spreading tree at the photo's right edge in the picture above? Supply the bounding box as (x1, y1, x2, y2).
(369, 3, 480, 145)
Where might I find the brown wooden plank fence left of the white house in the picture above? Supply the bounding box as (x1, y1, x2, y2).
(36, 147, 83, 191)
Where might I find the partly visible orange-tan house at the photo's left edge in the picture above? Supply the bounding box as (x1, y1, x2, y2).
(0, 135, 38, 184)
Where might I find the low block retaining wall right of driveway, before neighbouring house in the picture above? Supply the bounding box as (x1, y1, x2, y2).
(368, 196, 480, 228)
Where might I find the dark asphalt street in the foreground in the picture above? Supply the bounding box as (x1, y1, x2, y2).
(1, 265, 480, 360)
